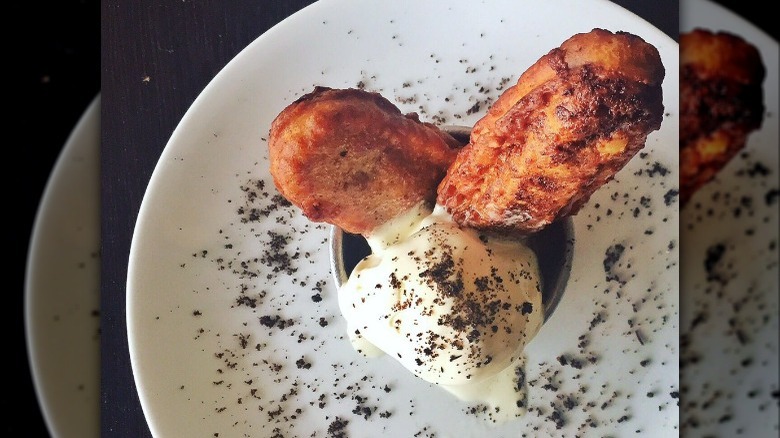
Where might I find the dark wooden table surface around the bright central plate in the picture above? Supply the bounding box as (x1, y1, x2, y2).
(91, 0, 768, 438)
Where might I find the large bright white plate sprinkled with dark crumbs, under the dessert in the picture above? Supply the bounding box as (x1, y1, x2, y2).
(127, 0, 678, 437)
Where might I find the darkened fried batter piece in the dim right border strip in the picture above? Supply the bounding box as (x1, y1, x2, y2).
(680, 29, 766, 205)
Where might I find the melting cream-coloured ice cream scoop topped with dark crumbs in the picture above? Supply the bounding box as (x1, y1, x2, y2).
(339, 206, 544, 386)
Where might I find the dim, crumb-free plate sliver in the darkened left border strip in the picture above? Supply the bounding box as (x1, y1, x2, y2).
(25, 96, 100, 438)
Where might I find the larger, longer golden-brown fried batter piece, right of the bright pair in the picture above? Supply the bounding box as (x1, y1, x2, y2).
(438, 29, 665, 234)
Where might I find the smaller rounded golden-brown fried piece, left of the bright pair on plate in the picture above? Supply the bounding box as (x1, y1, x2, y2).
(268, 87, 460, 236)
